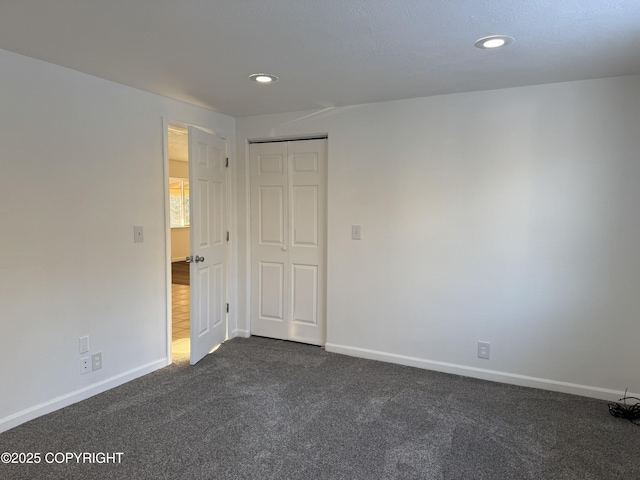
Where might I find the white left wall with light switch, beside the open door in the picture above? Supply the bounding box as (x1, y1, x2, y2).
(0, 51, 235, 431)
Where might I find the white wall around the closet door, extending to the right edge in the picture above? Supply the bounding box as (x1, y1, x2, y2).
(237, 76, 640, 399)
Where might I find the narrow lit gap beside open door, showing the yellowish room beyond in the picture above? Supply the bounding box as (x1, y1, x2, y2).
(167, 125, 191, 361)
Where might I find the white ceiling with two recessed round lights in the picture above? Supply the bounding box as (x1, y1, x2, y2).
(0, 0, 640, 117)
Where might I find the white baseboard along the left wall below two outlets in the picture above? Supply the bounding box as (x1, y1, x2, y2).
(0, 358, 170, 433)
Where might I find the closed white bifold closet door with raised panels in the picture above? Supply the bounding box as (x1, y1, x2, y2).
(250, 139, 327, 345)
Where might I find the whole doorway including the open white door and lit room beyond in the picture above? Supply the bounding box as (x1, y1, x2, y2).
(164, 122, 229, 365)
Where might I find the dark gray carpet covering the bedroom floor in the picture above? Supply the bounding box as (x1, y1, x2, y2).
(0, 337, 640, 480)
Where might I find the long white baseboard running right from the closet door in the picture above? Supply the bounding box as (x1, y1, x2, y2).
(325, 343, 640, 401)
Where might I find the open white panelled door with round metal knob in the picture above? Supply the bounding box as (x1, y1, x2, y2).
(188, 127, 227, 365)
